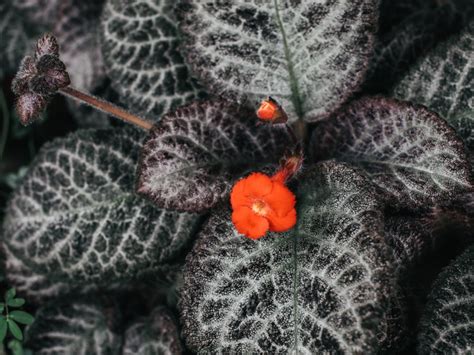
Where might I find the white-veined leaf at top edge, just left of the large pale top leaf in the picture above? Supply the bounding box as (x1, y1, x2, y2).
(101, 0, 203, 121)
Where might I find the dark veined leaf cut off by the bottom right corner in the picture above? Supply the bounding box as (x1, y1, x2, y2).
(417, 247, 474, 355)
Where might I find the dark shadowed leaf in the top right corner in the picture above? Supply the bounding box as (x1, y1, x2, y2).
(366, 0, 474, 93)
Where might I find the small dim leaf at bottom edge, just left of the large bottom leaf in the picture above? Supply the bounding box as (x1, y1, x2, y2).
(123, 307, 183, 355)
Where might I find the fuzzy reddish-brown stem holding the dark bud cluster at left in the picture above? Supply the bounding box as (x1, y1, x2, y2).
(59, 86, 153, 130)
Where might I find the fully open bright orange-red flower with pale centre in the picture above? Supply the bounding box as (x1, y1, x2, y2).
(230, 171, 296, 239)
